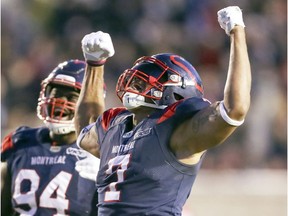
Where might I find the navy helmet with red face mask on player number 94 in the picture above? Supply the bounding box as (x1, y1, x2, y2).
(37, 60, 86, 134)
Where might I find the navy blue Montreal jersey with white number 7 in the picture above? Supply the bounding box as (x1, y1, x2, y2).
(92, 98, 210, 216)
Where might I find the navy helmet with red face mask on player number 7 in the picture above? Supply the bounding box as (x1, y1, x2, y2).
(116, 53, 203, 109)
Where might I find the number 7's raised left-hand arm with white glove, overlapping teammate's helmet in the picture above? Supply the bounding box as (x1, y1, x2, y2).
(75, 31, 115, 157)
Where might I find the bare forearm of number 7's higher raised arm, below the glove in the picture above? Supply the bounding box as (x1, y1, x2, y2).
(224, 26, 251, 120)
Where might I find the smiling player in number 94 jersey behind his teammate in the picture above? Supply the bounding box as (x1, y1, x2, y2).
(1, 60, 103, 216)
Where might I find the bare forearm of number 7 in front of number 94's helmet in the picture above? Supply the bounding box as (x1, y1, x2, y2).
(75, 65, 105, 135)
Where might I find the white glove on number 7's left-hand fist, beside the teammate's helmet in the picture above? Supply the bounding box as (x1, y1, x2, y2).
(81, 31, 115, 66)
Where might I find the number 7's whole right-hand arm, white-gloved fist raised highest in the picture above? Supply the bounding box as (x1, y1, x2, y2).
(170, 6, 251, 164)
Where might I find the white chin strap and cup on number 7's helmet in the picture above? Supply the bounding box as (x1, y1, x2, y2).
(122, 92, 167, 109)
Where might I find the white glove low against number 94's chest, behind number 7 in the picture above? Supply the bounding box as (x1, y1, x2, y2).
(75, 152, 100, 182)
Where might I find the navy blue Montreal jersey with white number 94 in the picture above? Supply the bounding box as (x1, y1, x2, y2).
(1, 127, 97, 216)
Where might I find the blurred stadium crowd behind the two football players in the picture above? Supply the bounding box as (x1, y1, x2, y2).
(1, 0, 287, 169)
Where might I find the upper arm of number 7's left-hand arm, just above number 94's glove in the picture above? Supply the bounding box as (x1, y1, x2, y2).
(77, 124, 99, 157)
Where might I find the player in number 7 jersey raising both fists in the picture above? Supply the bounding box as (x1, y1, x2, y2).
(75, 6, 251, 216)
